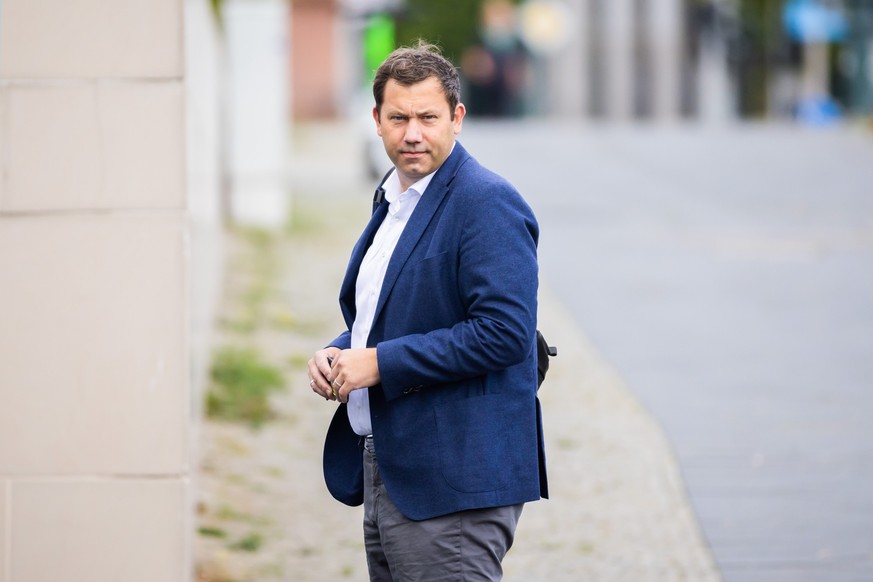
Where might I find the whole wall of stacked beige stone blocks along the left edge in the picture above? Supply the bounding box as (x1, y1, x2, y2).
(0, 0, 207, 582)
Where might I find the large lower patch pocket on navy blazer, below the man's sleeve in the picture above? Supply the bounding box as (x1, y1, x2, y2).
(434, 394, 512, 493)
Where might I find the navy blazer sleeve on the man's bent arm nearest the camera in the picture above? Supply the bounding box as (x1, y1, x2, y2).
(377, 173, 539, 400)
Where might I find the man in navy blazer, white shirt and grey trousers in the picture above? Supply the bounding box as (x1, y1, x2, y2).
(309, 43, 547, 582)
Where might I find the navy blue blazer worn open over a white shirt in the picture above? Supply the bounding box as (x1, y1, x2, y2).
(324, 143, 548, 520)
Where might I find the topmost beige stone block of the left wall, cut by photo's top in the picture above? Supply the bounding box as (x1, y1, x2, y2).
(0, 0, 184, 79)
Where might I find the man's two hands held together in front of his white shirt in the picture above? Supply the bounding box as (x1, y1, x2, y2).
(309, 348, 381, 402)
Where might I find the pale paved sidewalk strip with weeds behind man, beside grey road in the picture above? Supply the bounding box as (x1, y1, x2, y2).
(194, 125, 719, 582)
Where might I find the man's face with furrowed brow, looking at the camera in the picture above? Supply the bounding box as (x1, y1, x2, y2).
(373, 77, 466, 190)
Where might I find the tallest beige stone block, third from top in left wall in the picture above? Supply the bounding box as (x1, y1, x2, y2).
(0, 214, 190, 475)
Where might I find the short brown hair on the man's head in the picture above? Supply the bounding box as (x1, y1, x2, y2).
(373, 40, 461, 119)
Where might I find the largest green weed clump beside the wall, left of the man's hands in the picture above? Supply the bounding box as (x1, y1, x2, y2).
(206, 347, 285, 427)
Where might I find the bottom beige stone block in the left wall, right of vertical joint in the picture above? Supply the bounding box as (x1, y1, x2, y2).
(9, 480, 190, 582)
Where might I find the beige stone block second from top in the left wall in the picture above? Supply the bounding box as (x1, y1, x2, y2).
(0, 82, 184, 212)
